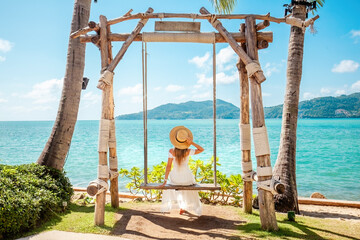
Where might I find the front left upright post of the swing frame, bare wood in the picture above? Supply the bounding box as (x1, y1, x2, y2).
(95, 15, 113, 226)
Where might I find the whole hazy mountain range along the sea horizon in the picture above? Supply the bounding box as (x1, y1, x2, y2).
(116, 93, 360, 120)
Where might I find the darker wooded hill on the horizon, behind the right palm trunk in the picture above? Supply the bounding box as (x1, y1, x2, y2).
(264, 92, 360, 118)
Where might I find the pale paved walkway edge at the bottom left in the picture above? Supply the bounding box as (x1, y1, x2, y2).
(17, 230, 129, 240)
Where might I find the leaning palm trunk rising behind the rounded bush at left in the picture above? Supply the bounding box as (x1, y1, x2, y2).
(37, 0, 91, 170)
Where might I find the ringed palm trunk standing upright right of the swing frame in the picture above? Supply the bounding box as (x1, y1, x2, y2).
(273, 0, 306, 213)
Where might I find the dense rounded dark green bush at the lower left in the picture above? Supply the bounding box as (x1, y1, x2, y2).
(0, 163, 73, 236)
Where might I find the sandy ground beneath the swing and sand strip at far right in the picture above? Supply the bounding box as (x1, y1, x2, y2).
(73, 192, 360, 240)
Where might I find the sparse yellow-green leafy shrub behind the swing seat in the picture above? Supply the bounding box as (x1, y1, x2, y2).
(119, 157, 243, 206)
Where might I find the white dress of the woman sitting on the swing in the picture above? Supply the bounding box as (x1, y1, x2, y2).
(161, 149, 202, 216)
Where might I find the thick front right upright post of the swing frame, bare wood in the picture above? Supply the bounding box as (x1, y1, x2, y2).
(245, 17, 279, 231)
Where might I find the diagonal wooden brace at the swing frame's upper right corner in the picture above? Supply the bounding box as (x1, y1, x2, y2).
(200, 7, 266, 84)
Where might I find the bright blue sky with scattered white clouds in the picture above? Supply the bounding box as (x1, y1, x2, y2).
(0, 0, 360, 121)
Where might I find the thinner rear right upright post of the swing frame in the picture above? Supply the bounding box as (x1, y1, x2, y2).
(237, 23, 253, 213)
